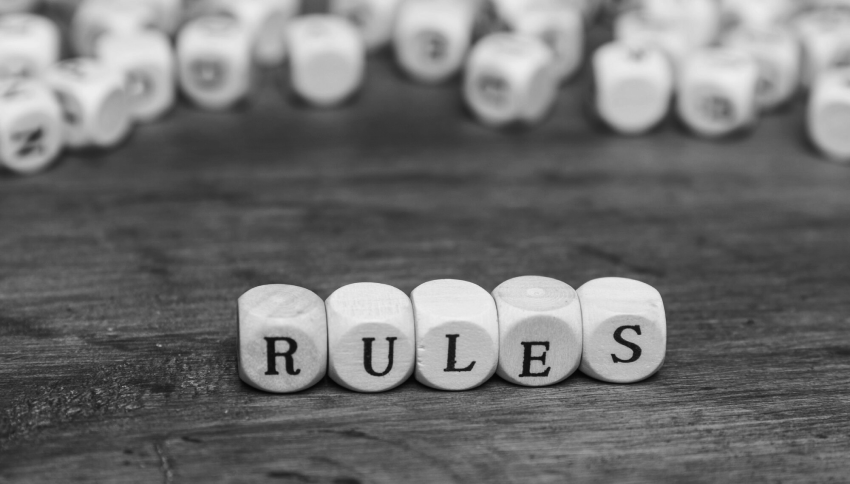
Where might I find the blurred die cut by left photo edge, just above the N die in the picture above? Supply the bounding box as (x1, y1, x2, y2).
(0, 13, 59, 79)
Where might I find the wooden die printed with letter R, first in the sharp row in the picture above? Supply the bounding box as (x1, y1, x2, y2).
(237, 284, 328, 393)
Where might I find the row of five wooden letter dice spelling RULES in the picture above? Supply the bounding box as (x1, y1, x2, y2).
(237, 276, 667, 393)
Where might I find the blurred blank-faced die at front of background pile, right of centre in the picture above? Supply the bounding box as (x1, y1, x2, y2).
(593, 42, 674, 134)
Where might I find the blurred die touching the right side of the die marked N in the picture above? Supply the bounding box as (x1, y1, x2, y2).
(45, 58, 132, 148)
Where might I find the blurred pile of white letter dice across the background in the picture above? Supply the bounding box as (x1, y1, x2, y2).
(0, 0, 850, 177)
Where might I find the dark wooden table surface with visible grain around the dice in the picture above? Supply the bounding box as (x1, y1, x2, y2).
(0, 29, 850, 484)
